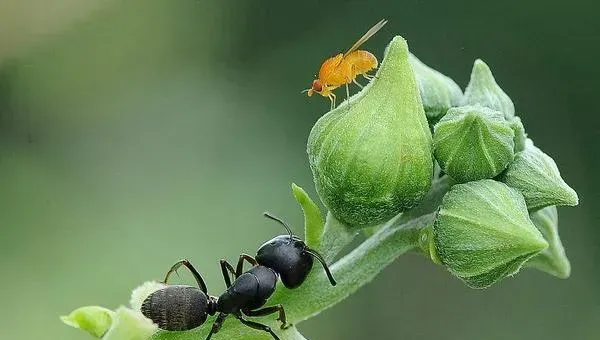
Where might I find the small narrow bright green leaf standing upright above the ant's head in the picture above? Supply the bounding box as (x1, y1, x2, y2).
(292, 183, 325, 249)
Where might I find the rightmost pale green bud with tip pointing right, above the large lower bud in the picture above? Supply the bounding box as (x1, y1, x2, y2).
(502, 139, 579, 211)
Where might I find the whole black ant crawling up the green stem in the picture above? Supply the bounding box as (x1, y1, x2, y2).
(141, 213, 336, 340)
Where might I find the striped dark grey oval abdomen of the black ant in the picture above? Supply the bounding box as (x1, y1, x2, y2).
(141, 285, 209, 331)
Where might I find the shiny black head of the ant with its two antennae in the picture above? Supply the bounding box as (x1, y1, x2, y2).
(256, 213, 336, 288)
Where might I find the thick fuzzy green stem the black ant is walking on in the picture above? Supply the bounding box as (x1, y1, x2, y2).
(153, 214, 434, 340)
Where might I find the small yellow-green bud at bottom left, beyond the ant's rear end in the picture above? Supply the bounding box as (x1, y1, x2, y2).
(60, 306, 115, 338)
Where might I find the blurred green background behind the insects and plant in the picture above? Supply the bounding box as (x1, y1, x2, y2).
(0, 0, 600, 340)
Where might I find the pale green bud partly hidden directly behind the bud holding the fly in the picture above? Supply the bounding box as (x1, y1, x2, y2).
(408, 54, 462, 124)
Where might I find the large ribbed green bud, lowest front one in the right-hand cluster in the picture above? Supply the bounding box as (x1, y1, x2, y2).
(433, 179, 548, 288)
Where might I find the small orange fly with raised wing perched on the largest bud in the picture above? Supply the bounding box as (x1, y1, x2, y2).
(302, 20, 387, 109)
